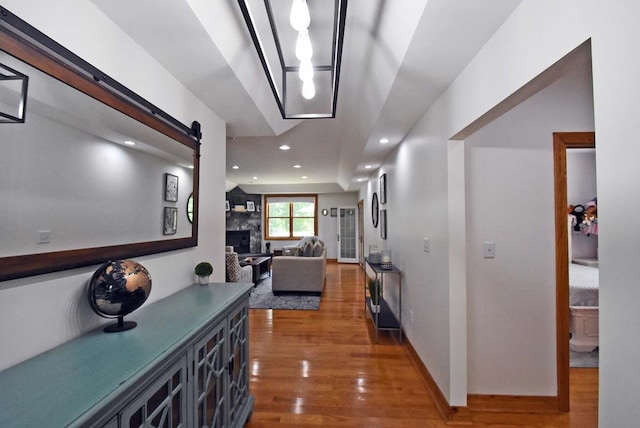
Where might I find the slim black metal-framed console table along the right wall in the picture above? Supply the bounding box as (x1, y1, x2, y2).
(364, 257, 402, 343)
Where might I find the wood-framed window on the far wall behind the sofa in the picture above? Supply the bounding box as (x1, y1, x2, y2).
(264, 195, 318, 240)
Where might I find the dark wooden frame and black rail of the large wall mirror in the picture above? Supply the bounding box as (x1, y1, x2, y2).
(0, 7, 201, 281)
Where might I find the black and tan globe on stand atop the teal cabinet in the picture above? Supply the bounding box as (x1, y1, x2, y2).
(87, 260, 151, 333)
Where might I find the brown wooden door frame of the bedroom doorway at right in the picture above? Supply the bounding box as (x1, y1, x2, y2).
(553, 132, 596, 412)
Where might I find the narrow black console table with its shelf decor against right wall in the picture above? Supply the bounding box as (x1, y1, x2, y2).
(364, 257, 402, 343)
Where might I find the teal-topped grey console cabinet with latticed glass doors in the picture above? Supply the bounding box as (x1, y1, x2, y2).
(0, 283, 254, 428)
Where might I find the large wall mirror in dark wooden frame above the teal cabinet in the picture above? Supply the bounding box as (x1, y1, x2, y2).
(0, 7, 201, 281)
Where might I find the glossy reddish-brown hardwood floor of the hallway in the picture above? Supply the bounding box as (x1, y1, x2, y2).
(247, 263, 598, 428)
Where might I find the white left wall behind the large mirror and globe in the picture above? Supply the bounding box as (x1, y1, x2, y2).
(0, 0, 225, 370)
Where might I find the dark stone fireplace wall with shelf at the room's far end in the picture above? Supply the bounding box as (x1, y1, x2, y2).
(226, 187, 263, 253)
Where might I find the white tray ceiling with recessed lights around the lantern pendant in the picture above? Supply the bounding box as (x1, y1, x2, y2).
(92, 0, 520, 193)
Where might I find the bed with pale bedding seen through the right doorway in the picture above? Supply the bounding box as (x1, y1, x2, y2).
(569, 263, 600, 352)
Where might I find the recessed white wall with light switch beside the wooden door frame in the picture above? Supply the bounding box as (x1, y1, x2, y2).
(464, 64, 593, 396)
